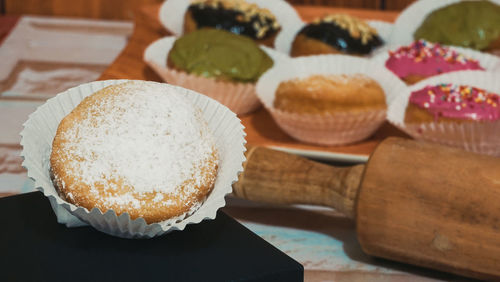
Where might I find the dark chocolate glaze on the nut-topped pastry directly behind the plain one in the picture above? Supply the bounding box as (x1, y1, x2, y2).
(299, 22, 383, 55)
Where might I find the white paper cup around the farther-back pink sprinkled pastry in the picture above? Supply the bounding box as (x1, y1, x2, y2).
(373, 41, 500, 78)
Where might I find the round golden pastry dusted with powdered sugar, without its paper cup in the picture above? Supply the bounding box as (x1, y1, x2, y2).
(50, 81, 218, 223)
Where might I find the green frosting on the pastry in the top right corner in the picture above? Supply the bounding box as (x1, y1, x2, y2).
(414, 1, 500, 50)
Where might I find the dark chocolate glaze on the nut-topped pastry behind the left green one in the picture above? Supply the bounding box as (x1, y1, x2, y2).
(188, 5, 277, 39)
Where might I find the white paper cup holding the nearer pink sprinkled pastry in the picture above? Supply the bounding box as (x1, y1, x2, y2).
(387, 71, 500, 156)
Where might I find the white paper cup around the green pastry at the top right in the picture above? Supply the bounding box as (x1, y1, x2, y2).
(389, 0, 500, 45)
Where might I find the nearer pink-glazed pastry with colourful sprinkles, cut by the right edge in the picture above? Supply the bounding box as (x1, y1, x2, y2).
(405, 84, 500, 123)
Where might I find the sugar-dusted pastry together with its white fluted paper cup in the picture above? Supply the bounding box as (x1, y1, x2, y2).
(22, 81, 244, 238)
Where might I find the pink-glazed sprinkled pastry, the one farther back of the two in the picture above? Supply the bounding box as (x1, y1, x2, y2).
(385, 40, 484, 84)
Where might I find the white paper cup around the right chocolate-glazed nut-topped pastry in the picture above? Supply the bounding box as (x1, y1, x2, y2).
(274, 20, 393, 55)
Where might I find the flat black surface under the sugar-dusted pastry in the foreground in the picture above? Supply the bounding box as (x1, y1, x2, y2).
(0, 192, 303, 282)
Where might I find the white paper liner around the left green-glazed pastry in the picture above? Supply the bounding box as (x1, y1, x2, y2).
(144, 35, 288, 115)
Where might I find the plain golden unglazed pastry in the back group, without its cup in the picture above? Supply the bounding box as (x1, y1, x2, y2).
(273, 74, 387, 115)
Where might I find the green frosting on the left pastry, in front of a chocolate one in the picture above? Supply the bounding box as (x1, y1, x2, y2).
(169, 29, 273, 82)
